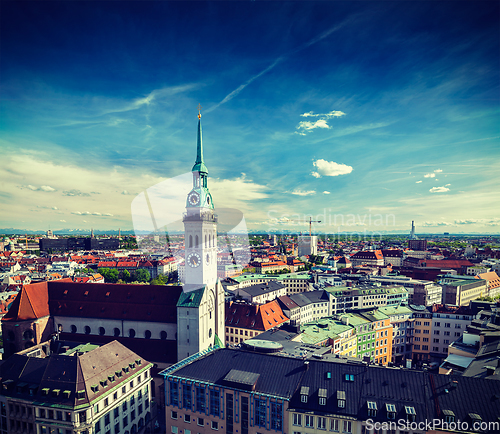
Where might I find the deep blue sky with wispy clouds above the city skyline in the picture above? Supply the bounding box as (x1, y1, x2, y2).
(0, 1, 500, 234)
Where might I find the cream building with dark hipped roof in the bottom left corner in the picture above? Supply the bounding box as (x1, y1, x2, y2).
(1, 341, 153, 434)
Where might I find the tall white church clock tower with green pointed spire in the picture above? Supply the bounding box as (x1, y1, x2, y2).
(177, 110, 225, 360)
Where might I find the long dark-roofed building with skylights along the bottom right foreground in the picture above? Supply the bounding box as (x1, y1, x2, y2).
(162, 346, 500, 434)
